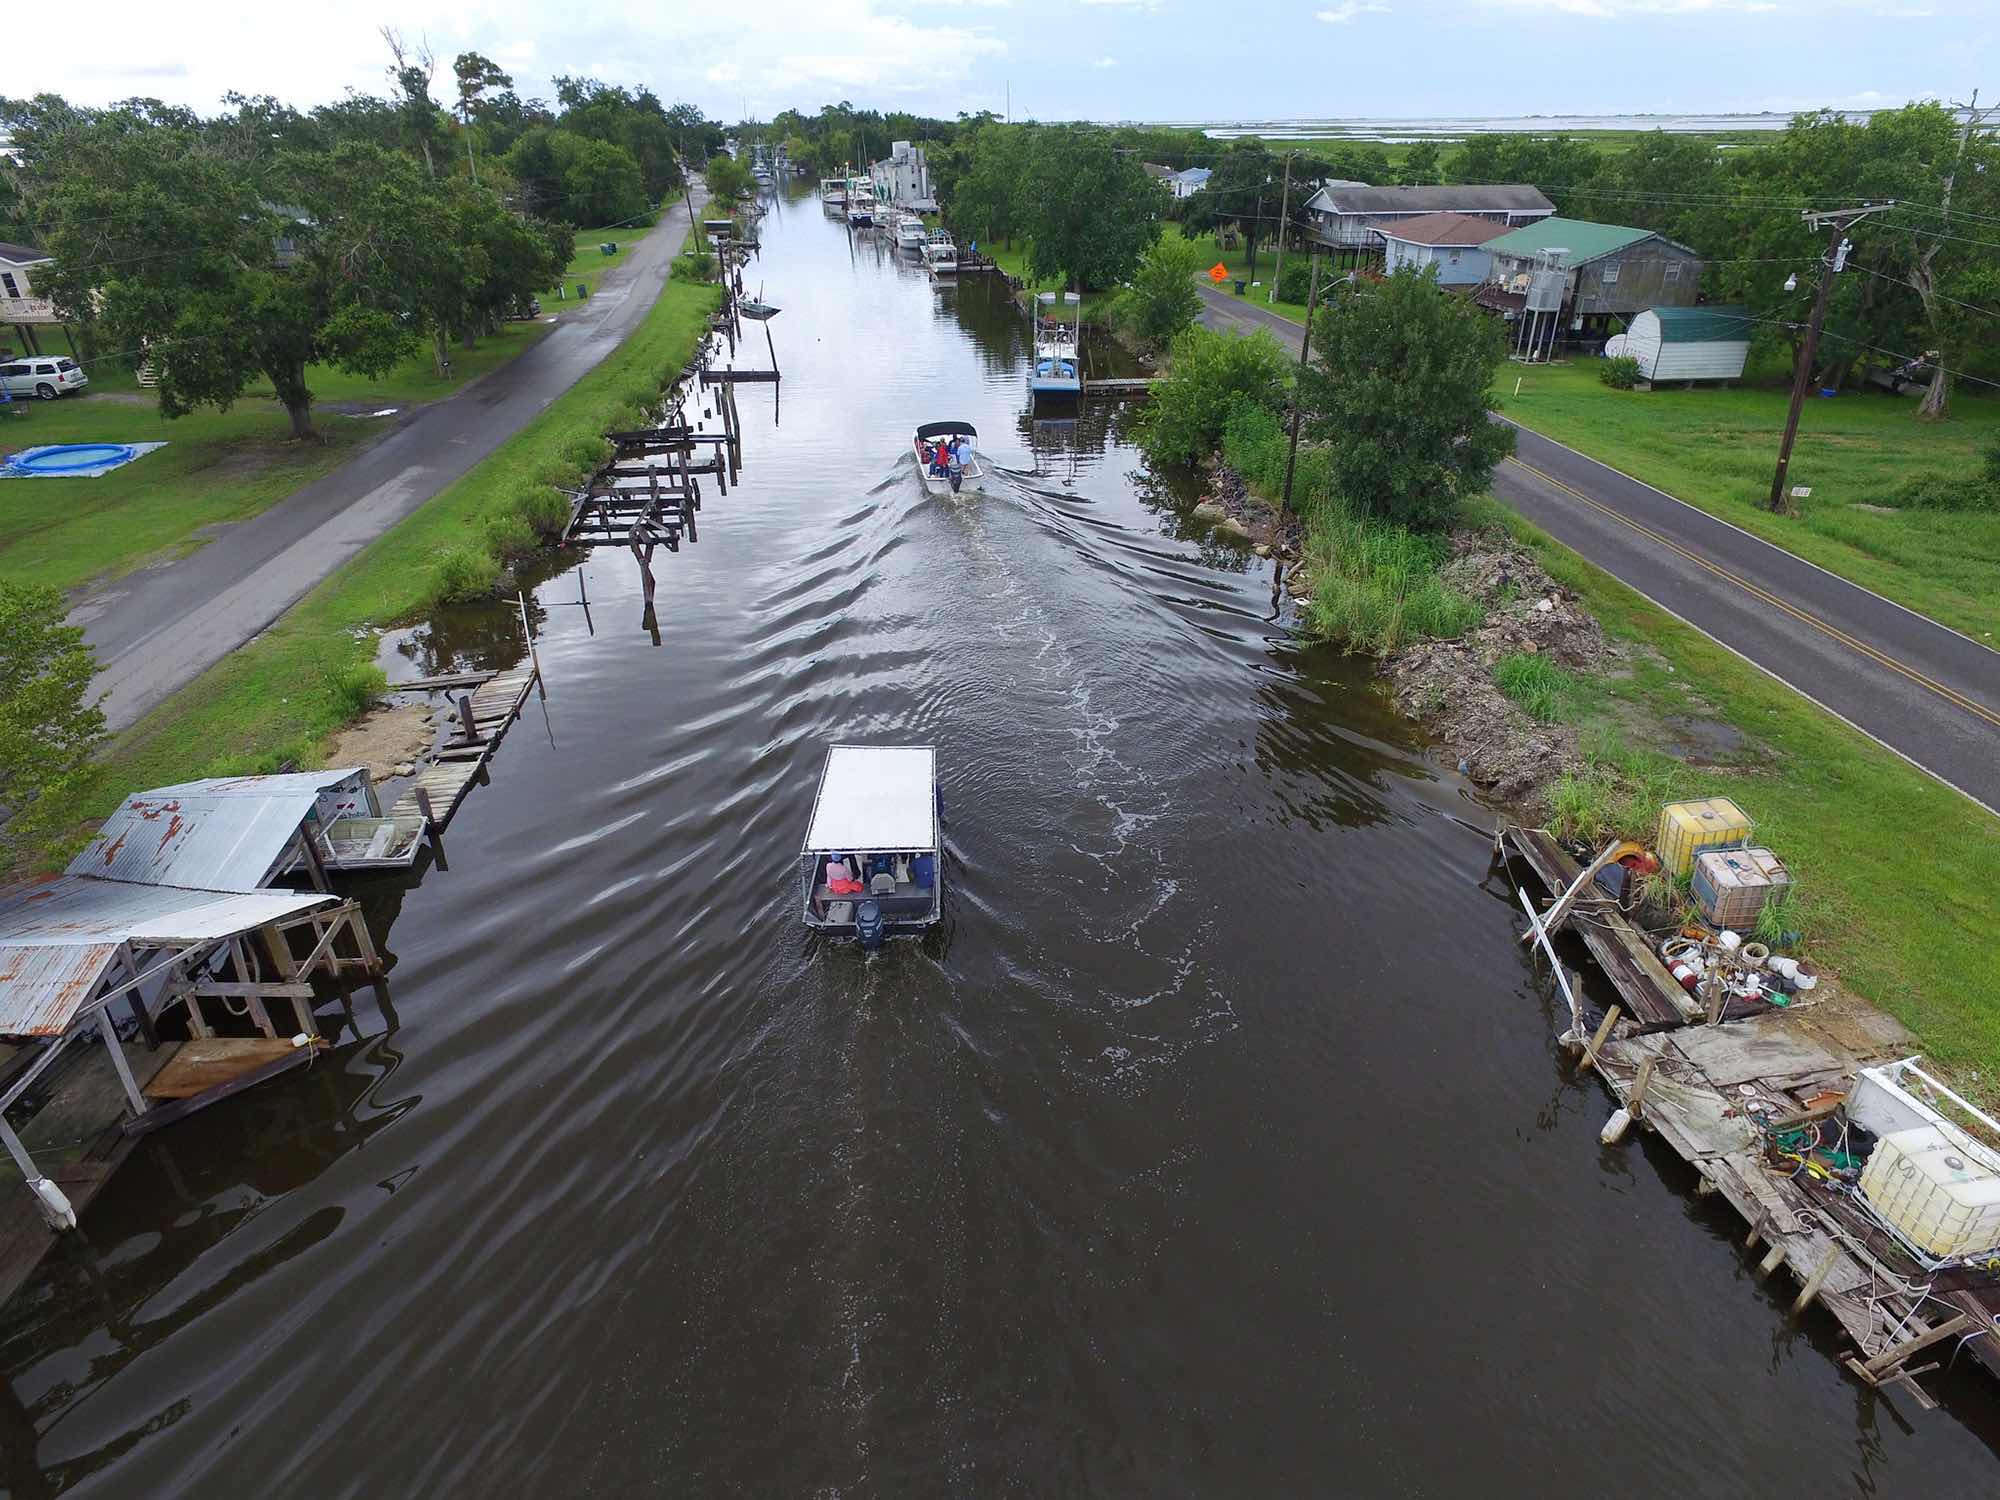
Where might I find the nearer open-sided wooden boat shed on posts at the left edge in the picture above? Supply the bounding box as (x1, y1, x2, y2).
(0, 856, 382, 1298)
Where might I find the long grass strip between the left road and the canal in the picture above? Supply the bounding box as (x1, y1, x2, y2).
(21, 282, 716, 860)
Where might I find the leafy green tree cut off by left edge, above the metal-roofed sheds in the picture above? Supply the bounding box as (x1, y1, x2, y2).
(0, 578, 104, 850)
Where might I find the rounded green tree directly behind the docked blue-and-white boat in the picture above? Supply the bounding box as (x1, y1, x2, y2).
(1020, 126, 1162, 290)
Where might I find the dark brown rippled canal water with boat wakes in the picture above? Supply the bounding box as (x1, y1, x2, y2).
(0, 200, 2000, 1496)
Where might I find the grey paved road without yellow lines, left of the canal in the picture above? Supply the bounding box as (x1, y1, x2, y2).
(70, 191, 704, 730)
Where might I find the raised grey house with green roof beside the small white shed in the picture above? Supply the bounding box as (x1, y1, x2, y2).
(1478, 218, 1702, 332)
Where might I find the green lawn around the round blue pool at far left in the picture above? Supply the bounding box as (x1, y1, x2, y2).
(0, 394, 390, 588)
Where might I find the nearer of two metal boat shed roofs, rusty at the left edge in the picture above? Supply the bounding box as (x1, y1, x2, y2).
(0, 874, 334, 1036)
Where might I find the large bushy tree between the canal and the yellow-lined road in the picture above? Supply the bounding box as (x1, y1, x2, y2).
(1300, 266, 1514, 526)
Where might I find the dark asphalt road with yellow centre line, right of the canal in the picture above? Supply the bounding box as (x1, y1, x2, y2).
(1202, 288, 2000, 812)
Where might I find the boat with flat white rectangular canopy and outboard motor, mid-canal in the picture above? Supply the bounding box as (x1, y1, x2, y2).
(798, 744, 944, 948)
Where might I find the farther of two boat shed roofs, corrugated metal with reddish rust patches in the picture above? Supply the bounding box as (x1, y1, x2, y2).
(70, 788, 318, 890)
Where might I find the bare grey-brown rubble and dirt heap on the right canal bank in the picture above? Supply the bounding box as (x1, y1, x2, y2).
(1382, 530, 1616, 814)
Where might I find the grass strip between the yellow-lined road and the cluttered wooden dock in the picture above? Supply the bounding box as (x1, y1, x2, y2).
(1474, 502, 2000, 1098)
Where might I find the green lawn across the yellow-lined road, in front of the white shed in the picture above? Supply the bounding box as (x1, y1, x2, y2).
(1496, 360, 2000, 640)
